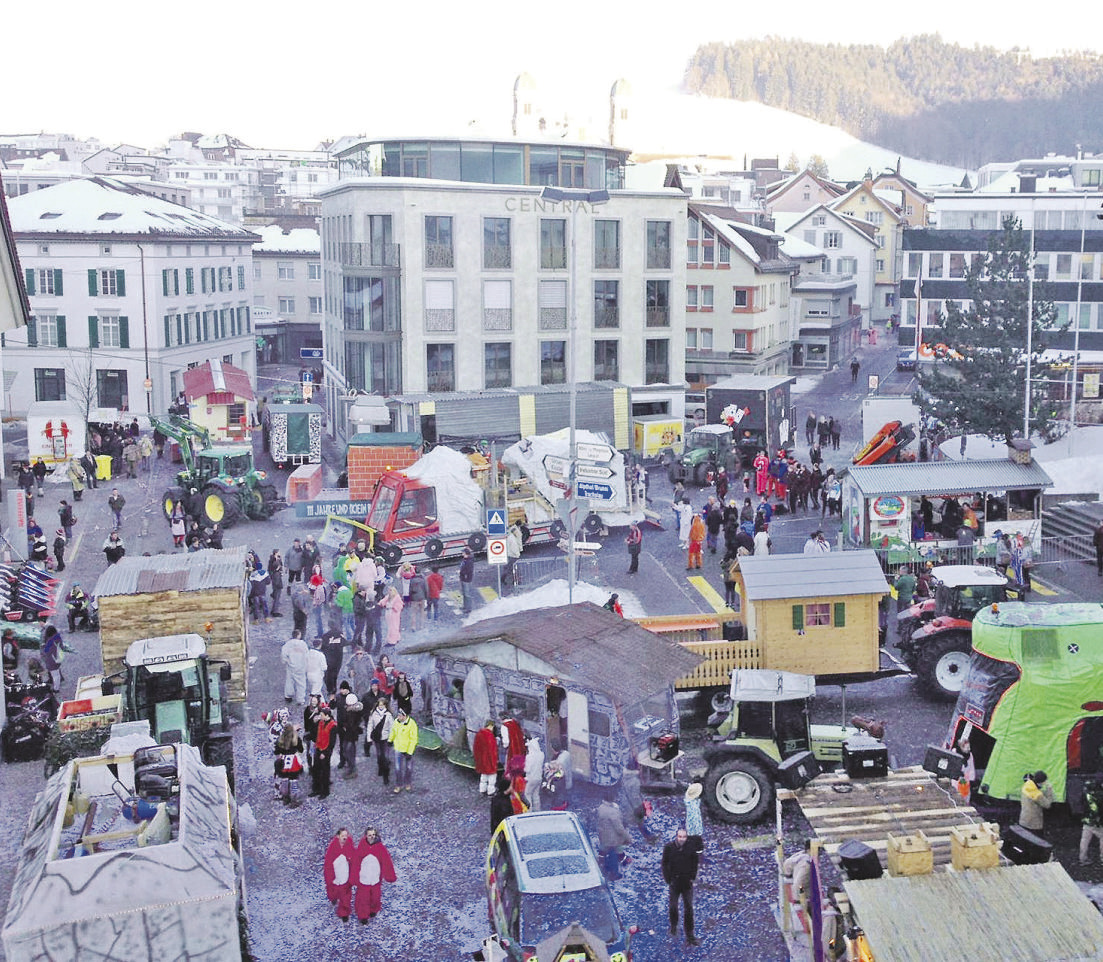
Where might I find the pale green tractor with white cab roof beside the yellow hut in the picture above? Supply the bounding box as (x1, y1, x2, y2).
(704, 669, 859, 824)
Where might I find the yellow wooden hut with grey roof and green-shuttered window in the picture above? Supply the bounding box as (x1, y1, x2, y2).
(737, 551, 888, 675)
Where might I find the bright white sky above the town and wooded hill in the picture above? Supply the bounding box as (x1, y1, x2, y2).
(0, 0, 1103, 149)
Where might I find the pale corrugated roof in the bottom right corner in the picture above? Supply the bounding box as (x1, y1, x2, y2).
(846, 862, 1103, 962)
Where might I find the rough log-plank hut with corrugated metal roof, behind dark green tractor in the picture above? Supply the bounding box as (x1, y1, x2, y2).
(95, 547, 246, 703)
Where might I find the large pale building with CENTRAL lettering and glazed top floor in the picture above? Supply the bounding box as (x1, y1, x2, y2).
(322, 141, 686, 443)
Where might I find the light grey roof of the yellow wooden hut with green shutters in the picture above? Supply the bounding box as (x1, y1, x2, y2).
(739, 551, 888, 601)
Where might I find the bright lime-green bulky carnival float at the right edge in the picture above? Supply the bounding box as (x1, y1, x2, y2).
(944, 601, 1103, 813)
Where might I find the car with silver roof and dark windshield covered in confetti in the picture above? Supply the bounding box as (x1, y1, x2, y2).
(486, 812, 634, 962)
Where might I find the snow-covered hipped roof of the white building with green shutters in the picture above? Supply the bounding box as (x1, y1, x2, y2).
(9, 177, 254, 243)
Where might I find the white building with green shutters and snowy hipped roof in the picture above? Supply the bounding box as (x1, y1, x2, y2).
(3, 178, 257, 414)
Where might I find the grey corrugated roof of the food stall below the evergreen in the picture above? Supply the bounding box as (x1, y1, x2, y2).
(847, 458, 1053, 498)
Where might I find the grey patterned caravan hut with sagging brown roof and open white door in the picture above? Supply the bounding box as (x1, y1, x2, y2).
(403, 601, 700, 785)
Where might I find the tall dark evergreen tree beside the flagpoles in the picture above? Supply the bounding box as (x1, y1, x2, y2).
(914, 216, 1057, 441)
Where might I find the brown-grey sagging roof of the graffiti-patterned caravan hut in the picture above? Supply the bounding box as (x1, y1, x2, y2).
(404, 601, 702, 705)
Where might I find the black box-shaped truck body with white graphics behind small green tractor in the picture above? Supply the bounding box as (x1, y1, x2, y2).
(705, 374, 796, 467)
